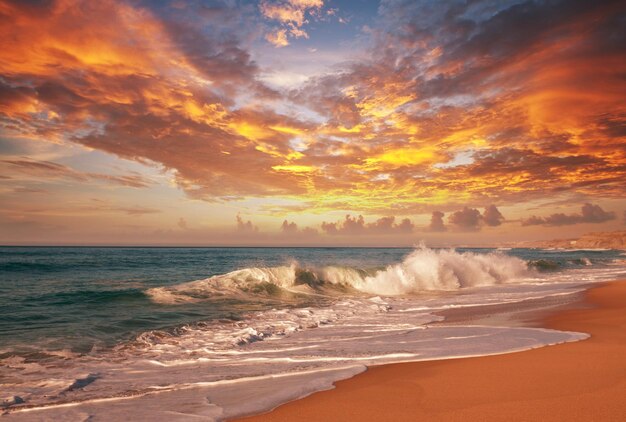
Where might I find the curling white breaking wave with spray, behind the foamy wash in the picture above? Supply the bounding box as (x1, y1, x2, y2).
(146, 247, 530, 304)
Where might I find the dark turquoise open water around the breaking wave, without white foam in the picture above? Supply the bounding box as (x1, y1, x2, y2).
(0, 247, 623, 357)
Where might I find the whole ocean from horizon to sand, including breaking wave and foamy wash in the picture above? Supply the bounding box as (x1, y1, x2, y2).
(0, 247, 626, 420)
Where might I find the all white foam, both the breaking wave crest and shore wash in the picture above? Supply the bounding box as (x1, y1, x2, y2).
(0, 248, 624, 421)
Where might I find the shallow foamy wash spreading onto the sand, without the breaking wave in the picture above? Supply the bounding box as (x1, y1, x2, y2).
(0, 276, 586, 421)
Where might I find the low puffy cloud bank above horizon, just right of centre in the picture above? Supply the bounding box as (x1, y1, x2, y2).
(322, 215, 415, 235)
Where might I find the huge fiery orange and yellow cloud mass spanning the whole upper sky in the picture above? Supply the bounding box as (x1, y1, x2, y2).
(0, 0, 626, 218)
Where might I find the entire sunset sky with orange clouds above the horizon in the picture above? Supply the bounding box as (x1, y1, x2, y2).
(0, 0, 626, 246)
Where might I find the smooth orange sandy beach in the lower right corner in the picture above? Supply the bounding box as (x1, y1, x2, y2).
(242, 280, 626, 422)
